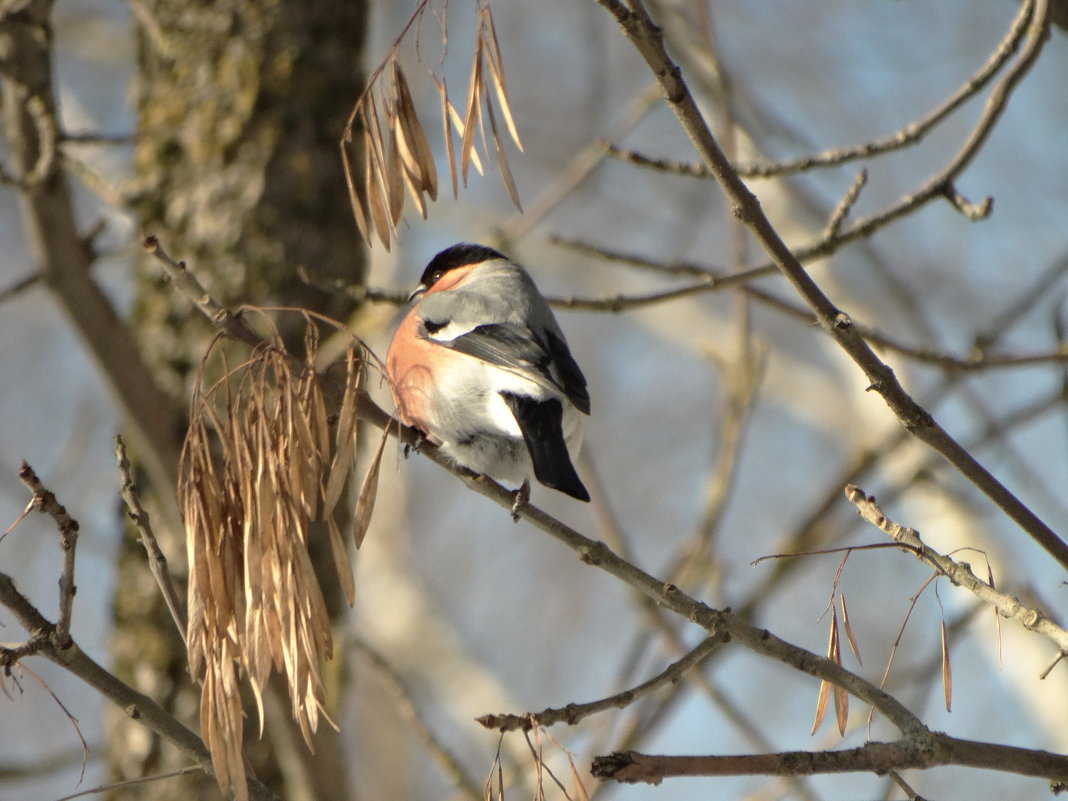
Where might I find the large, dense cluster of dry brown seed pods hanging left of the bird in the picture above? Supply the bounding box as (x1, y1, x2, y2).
(178, 319, 384, 799)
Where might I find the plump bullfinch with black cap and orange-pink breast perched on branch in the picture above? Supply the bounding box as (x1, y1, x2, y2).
(386, 244, 590, 514)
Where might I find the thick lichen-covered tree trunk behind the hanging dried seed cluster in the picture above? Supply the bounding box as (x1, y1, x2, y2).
(109, 0, 366, 801)
